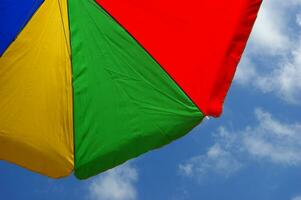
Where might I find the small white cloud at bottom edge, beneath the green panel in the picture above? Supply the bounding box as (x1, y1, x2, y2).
(89, 164, 138, 200)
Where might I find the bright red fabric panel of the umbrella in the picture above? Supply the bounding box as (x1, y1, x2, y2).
(96, 0, 261, 116)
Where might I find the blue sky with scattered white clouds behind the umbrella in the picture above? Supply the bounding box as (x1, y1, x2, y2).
(0, 0, 301, 200)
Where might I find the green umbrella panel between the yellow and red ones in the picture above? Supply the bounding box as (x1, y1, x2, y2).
(69, 0, 204, 179)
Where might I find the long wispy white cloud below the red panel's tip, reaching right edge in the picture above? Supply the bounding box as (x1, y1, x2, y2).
(179, 109, 301, 178)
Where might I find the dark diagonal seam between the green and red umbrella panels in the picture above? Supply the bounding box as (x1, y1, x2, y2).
(93, 0, 205, 116)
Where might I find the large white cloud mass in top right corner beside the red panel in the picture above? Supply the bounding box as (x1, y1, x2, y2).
(235, 0, 301, 105)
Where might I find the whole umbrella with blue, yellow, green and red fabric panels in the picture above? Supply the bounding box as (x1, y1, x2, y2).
(0, 0, 261, 179)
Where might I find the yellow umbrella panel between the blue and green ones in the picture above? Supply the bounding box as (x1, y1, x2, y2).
(0, 0, 73, 178)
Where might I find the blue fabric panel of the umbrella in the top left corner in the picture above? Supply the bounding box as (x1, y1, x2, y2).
(0, 0, 44, 56)
